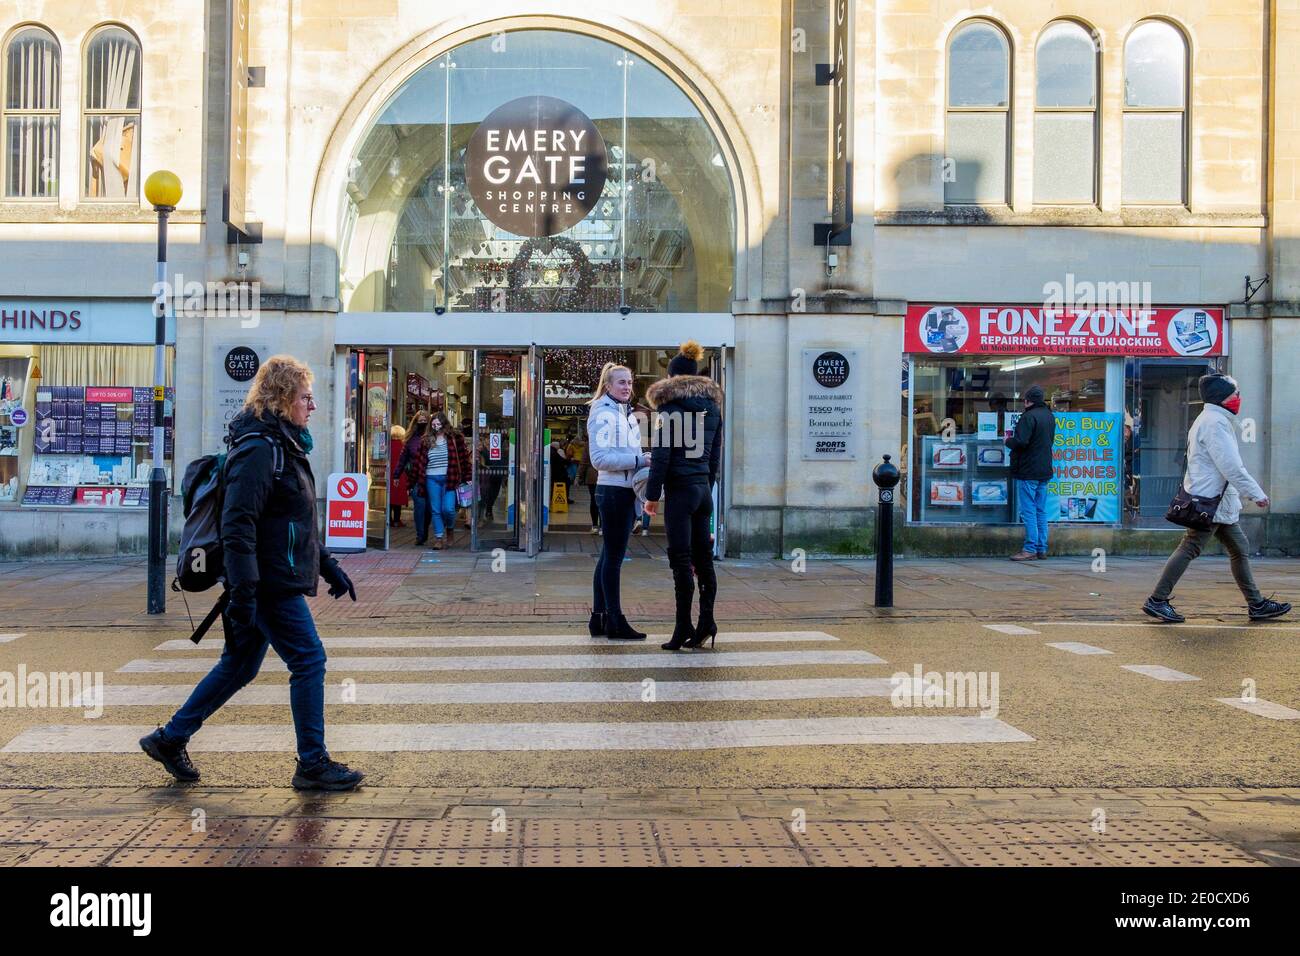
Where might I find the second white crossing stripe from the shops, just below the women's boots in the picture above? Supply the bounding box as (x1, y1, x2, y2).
(117, 650, 885, 674)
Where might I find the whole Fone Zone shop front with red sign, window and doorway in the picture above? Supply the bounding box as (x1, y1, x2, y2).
(902, 303, 1229, 528)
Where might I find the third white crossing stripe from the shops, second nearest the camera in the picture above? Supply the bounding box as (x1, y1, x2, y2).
(74, 678, 935, 708)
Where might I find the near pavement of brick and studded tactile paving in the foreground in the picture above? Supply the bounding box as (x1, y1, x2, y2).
(0, 787, 1300, 866)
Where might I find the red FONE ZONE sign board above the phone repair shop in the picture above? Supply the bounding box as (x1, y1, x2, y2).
(904, 306, 1225, 356)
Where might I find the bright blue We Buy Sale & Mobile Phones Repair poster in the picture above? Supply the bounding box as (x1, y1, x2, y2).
(1047, 411, 1125, 524)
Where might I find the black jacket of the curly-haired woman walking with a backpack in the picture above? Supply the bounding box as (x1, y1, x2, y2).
(221, 411, 332, 600)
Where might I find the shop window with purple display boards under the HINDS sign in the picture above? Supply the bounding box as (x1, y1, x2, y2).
(0, 345, 174, 509)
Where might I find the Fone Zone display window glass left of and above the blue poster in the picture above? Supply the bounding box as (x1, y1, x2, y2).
(902, 355, 1106, 524)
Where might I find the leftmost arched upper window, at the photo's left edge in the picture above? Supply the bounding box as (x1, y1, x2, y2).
(0, 26, 60, 199)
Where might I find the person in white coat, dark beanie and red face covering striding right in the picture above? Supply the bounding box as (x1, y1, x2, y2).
(1143, 373, 1291, 624)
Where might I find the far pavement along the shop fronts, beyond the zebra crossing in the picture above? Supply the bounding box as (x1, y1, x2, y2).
(0, 548, 1300, 631)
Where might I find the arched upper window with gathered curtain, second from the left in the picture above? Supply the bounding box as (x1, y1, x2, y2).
(82, 26, 140, 202)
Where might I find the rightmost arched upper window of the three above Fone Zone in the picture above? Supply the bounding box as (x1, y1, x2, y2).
(1122, 20, 1187, 204)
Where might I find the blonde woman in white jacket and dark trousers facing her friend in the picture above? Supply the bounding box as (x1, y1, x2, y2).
(586, 362, 650, 640)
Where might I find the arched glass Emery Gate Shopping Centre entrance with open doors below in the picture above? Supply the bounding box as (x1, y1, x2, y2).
(325, 30, 736, 554)
